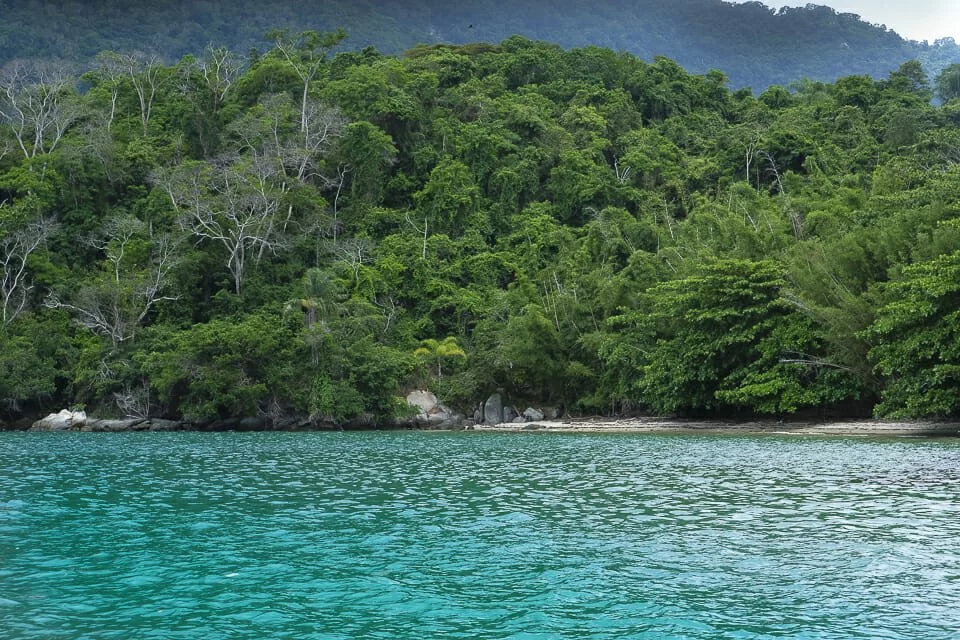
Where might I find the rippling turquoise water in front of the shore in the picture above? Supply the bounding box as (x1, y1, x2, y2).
(0, 433, 960, 640)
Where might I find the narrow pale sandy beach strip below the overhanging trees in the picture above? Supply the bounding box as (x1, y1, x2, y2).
(468, 418, 960, 437)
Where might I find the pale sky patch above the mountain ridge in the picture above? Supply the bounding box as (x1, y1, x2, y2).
(733, 0, 960, 42)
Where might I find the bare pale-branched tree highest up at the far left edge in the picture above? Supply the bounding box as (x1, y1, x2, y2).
(0, 60, 80, 158)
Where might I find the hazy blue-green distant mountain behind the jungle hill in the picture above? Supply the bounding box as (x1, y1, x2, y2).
(0, 0, 960, 90)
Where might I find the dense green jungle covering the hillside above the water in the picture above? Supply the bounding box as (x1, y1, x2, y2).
(0, 32, 960, 422)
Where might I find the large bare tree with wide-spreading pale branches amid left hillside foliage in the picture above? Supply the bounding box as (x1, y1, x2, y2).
(154, 157, 290, 294)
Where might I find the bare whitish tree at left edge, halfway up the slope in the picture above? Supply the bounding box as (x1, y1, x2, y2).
(0, 217, 57, 327)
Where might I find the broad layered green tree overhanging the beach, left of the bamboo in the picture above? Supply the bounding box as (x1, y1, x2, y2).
(608, 259, 852, 415)
